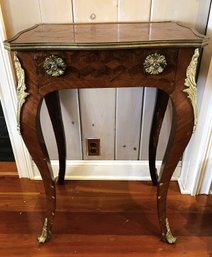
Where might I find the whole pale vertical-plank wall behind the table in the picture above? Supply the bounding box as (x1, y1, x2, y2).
(1, 0, 209, 168)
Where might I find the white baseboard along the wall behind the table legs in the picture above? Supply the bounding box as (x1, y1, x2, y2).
(34, 160, 181, 181)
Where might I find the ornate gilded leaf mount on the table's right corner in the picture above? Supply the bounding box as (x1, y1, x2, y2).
(183, 48, 199, 131)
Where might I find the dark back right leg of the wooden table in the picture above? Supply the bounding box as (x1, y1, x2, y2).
(149, 89, 169, 185)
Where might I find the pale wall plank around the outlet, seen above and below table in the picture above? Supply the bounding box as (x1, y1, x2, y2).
(73, 0, 118, 159)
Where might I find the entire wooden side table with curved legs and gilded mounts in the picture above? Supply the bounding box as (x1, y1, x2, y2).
(4, 22, 207, 243)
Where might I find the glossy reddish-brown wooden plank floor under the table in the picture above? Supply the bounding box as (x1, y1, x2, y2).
(0, 176, 212, 257)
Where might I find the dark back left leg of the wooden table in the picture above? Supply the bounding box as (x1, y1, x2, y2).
(45, 91, 66, 184)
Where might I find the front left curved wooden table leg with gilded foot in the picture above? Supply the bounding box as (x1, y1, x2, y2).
(20, 94, 56, 243)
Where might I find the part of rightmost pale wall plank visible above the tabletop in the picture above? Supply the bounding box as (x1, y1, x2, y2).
(151, 0, 200, 25)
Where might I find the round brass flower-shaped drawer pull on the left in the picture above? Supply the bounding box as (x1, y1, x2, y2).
(43, 55, 66, 77)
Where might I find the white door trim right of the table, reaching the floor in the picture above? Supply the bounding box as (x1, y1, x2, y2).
(179, 59, 212, 195)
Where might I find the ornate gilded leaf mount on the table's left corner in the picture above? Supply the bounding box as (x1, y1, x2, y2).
(14, 54, 29, 133)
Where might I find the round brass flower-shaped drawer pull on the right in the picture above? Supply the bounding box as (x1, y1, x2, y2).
(144, 53, 167, 75)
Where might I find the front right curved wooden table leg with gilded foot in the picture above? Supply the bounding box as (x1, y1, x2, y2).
(157, 92, 194, 244)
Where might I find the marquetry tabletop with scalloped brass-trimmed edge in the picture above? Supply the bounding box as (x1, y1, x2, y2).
(4, 22, 207, 51)
